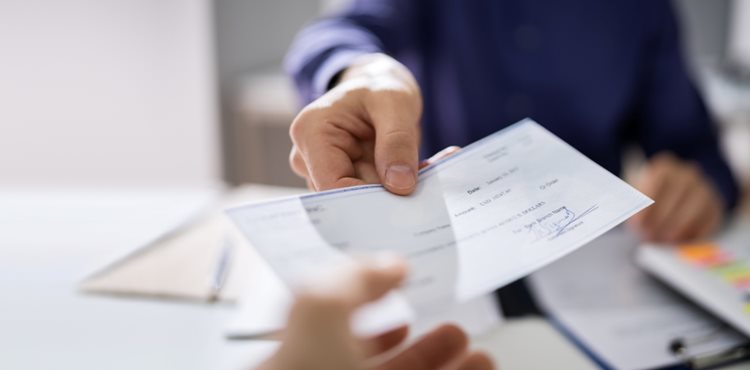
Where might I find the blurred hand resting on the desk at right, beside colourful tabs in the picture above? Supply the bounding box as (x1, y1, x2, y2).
(629, 153, 724, 243)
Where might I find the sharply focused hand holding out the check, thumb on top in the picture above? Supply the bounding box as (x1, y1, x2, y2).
(289, 54, 422, 195)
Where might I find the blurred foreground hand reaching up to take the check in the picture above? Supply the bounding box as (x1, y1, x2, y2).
(257, 260, 494, 370)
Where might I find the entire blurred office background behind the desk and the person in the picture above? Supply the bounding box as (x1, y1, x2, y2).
(0, 0, 750, 186)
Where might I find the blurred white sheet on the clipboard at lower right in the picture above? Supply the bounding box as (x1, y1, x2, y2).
(530, 228, 747, 370)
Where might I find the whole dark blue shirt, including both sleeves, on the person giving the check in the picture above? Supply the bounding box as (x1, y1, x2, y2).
(286, 0, 738, 207)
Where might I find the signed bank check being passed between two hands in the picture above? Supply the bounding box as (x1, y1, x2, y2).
(228, 119, 652, 332)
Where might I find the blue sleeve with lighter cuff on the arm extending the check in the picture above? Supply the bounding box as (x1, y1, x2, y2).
(284, 0, 417, 104)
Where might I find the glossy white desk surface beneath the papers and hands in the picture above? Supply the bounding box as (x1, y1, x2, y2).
(0, 189, 656, 370)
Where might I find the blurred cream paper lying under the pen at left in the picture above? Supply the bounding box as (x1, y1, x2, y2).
(79, 184, 305, 302)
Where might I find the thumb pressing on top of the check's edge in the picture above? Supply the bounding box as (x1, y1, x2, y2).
(375, 111, 419, 195)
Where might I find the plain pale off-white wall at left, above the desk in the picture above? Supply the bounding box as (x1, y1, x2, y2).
(0, 0, 222, 186)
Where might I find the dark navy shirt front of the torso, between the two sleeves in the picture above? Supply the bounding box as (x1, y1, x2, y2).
(402, 0, 656, 172)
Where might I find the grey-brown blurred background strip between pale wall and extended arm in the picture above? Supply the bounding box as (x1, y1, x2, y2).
(214, 0, 346, 186)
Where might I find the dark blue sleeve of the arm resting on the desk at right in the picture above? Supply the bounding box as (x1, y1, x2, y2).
(637, 0, 739, 210)
